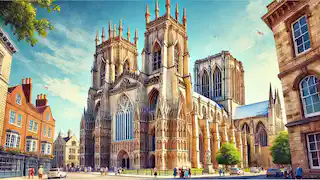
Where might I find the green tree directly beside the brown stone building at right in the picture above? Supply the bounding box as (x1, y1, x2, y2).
(270, 131, 291, 164)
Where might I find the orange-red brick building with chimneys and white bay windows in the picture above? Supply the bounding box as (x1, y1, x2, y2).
(2, 78, 55, 157)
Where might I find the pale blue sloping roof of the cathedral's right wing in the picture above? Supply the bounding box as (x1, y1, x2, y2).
(232, 101, 269, 119)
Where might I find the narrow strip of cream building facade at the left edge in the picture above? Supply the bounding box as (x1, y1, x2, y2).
(0, 28, 17, 144)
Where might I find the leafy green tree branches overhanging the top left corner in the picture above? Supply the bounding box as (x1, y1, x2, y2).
(0, 0, 60, 46)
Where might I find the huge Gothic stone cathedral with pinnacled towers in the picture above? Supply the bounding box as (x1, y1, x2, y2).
(80, 0, 284, 172)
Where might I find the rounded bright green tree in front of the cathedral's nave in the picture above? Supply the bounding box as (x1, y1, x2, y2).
(216, 143, 241, 165)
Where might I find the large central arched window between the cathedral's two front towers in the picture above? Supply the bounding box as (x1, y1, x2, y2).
(115, 95, 133, 141)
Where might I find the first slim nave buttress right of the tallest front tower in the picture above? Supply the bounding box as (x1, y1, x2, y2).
(191, 112, 200, 168)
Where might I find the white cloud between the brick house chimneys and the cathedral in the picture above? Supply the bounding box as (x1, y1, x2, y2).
(38, 77, 87, 107)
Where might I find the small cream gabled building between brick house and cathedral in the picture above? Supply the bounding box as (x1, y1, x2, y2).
(53, 130, 80, 168)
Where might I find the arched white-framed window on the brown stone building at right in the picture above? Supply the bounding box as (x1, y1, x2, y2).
(300, 75, 320, 117)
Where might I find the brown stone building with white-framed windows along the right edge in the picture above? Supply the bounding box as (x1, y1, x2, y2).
(262, 0, 320, 178)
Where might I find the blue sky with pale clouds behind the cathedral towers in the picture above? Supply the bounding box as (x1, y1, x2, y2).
(2, 0, 281, 139)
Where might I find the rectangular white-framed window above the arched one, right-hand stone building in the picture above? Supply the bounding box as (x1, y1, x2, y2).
(292, 15, 311, 56)
